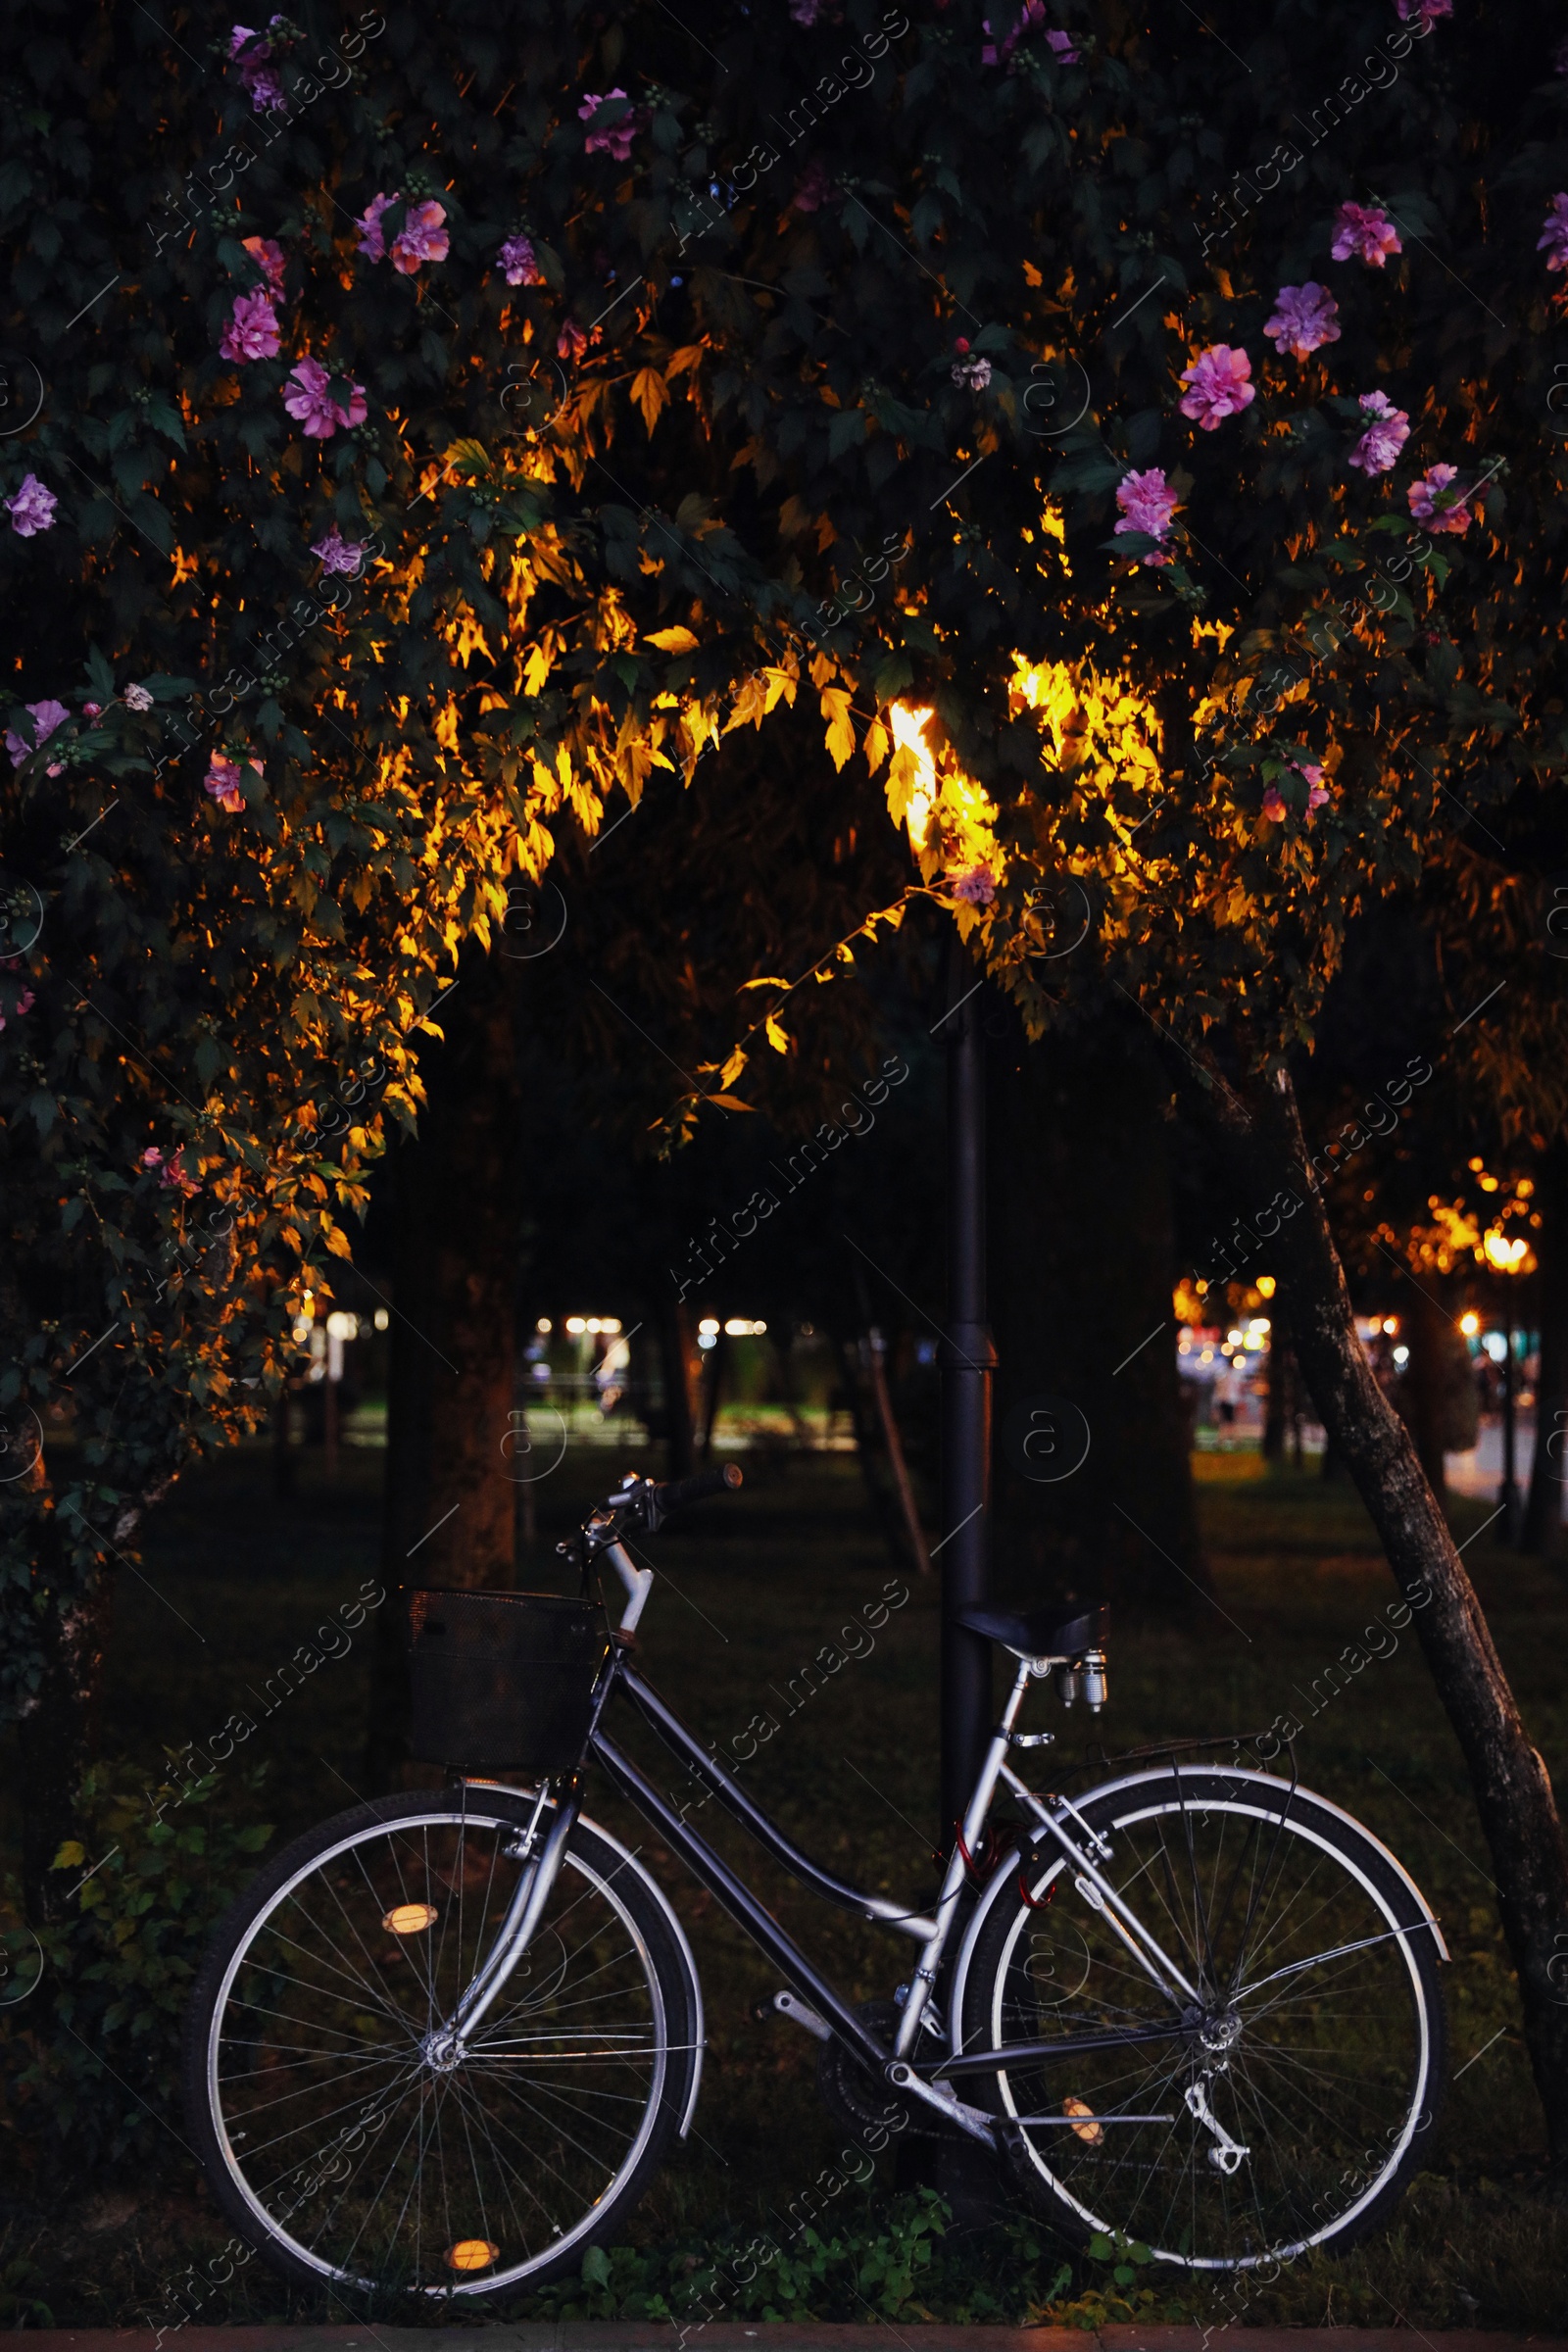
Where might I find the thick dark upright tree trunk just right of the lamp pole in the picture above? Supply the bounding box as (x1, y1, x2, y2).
(987, 1013, 1208, 1611)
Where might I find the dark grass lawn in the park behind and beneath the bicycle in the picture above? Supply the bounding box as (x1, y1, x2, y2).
(0, 1448, 1568, 2328)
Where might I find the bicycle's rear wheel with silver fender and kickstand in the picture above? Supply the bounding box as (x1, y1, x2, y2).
(959, 1766, 1446, 2270)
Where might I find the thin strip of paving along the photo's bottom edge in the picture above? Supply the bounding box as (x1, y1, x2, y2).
(25, 2319, 1568, 2352)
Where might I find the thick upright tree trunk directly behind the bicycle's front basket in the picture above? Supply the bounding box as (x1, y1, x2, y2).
(367, 955, 522, 1789)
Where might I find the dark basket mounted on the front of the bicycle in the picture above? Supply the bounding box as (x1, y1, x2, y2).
(409, 1590, 604, 1776)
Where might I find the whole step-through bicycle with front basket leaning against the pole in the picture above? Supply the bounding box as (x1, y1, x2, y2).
(186, 1465, 1448, 2298)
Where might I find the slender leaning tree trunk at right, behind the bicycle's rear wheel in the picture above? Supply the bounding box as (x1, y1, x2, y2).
(1192, 1072, 1568, 2164)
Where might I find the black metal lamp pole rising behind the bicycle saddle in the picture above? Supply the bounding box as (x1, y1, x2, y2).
(941, 939, 997, 1844)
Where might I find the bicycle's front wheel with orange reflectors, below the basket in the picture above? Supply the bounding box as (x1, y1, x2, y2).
(186, 1788, 701, 2298)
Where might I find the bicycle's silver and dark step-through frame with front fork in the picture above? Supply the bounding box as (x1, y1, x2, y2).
(428, 1541, 1199, 2145)
